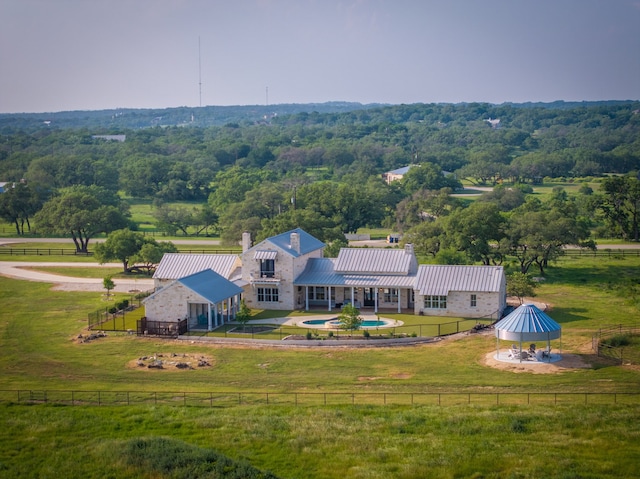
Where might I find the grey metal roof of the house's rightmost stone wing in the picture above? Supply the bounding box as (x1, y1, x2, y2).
(415, 265, 504, 296)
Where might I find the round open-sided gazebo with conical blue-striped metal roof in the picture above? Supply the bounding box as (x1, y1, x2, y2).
(494, 304, 561, 362)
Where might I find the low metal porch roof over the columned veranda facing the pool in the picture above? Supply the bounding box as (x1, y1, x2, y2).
(293, 258, 416, 288)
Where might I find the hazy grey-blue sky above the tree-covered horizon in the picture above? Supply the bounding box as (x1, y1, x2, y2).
(0, 0, 640, 113)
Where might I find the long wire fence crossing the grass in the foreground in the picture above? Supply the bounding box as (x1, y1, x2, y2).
(0, 389, 640, 407)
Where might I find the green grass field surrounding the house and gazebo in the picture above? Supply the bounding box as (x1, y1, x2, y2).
(0, 253, 640, 478)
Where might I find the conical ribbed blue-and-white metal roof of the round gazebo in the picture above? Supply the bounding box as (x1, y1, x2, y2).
(495, 304, 561, 341)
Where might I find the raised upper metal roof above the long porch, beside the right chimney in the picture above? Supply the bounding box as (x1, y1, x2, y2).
(335, 248, 418, 275)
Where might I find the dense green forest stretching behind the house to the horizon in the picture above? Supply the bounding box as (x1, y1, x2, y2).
(0, 101, 640, 272)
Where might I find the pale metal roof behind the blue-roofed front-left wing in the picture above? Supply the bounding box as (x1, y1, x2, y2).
(153, 253, 239, 279)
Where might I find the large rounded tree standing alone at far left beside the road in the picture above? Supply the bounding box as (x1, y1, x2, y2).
(34, 186, 129, 253)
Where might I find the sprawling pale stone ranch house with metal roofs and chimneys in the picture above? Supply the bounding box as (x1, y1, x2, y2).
(146, 228, 506, 328)
